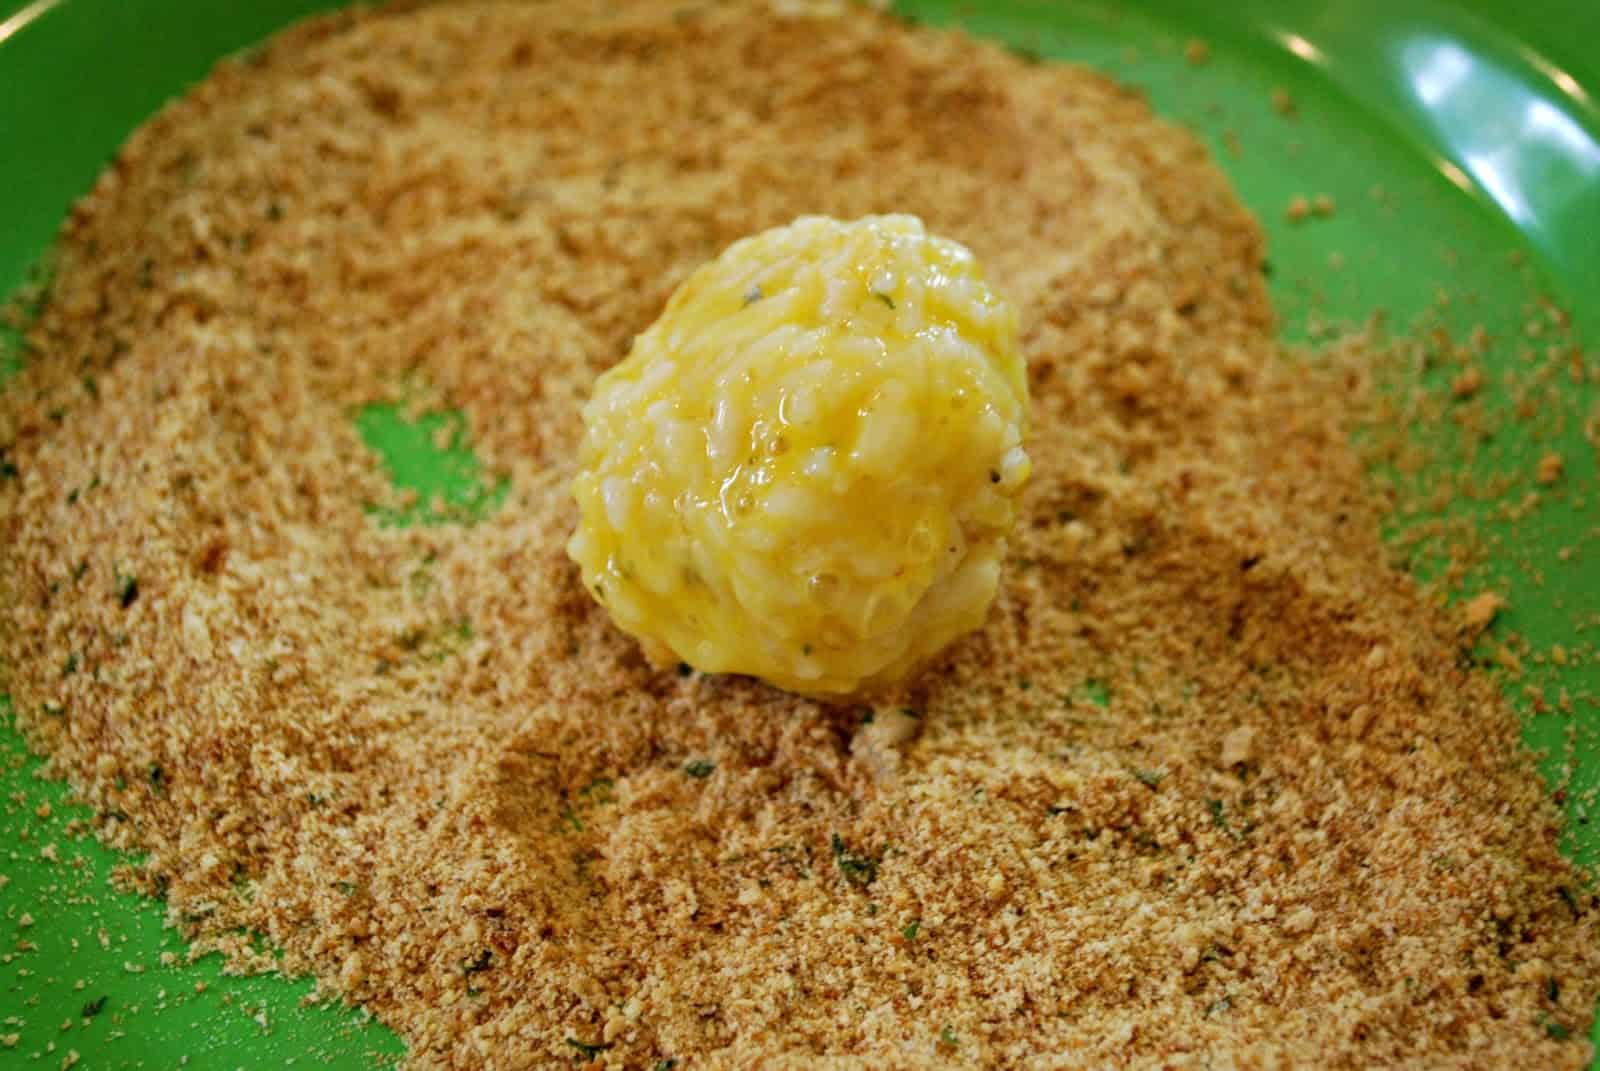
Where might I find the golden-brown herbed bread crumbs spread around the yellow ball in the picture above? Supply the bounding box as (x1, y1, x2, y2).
(0, 3, 1600, 1069)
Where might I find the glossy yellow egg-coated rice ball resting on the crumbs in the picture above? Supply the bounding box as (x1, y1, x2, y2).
(568, 216, 1029, 696)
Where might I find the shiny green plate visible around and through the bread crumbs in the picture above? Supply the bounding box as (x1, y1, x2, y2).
(0, 0, 1600, 1068)
